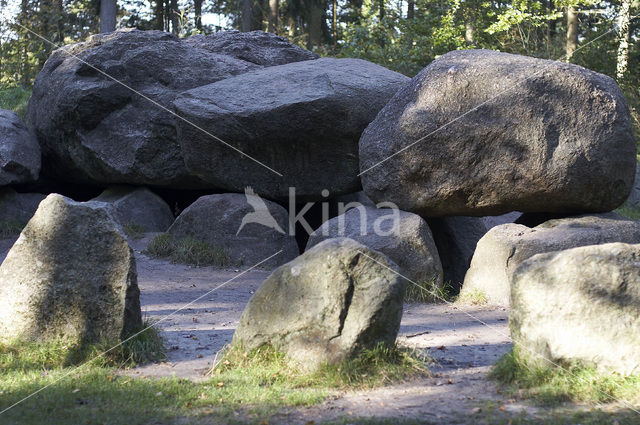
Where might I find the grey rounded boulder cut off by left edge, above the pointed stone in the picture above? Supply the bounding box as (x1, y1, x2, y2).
(0, 109, 40, 186)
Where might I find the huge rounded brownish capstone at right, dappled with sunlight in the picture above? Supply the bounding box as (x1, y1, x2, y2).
(360, 50, 636, 217)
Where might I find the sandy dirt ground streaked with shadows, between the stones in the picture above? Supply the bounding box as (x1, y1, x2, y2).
(121, 238, 552, 424)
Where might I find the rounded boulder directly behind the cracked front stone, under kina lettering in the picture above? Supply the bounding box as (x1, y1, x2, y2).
(306, 207, 442, 286)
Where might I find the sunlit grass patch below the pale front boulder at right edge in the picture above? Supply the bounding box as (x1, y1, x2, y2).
(490, 349, 640, 405)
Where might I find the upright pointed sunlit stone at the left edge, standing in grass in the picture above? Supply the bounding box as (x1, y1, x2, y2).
(0, 194, 142, 342)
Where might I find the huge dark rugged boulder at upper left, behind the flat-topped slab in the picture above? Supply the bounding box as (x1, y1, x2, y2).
(26, 30, 315, 188)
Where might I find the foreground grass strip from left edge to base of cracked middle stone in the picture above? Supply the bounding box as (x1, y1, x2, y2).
(0, 340, 429, 425)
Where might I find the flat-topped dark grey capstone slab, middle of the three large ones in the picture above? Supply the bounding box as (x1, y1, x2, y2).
(174, 58, 408, 201)
